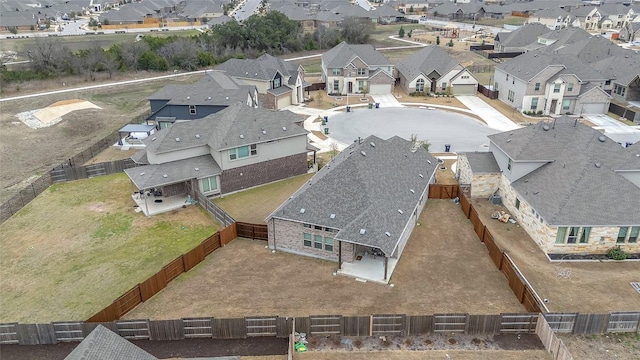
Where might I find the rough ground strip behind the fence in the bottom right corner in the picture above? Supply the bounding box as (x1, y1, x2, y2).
(558, 333, 640, 360)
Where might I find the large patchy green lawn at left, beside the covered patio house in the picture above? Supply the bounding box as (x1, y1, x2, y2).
(0, 174, 217, 323)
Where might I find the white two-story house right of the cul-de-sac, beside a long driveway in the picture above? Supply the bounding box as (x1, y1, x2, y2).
(494, 50, 610, 115)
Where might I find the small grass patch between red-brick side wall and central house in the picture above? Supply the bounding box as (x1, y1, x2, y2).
(213, 174, 312, 224)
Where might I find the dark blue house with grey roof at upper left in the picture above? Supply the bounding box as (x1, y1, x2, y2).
(147, 71, 258, 129)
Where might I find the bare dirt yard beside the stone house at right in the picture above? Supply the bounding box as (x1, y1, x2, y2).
(473, 199, 640, 313)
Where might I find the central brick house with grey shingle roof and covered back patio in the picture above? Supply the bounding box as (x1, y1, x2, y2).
(265, 136, 437, 283)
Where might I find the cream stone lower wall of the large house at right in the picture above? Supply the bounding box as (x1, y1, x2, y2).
(500, 176, 640, 254)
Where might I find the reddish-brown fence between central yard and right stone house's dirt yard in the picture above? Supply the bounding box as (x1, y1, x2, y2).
(458, 190, 548, 312)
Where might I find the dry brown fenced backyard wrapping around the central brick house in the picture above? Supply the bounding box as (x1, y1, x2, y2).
(125, 200, 524, 319)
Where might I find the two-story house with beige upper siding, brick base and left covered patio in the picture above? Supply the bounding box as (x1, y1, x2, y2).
(125, 103, 308, 215)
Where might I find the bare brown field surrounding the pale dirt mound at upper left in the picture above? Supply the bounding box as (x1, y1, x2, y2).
(0, 75, 200, 201)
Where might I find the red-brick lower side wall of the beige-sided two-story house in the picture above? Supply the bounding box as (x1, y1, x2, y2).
(220, 153, 307, 194)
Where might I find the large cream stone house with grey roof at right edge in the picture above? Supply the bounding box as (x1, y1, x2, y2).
(457, 116, 640, 259)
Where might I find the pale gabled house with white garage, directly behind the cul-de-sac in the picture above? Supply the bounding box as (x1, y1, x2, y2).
(396, 45, 478, 95)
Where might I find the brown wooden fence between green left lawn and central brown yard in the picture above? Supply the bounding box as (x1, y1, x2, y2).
(87, 223, 237, 322)
